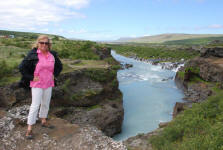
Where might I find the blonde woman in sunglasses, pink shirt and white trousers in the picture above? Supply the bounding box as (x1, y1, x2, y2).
(19, 35, 62, 139)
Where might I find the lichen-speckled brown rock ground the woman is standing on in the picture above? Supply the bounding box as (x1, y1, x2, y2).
(0, 106, 126, 150)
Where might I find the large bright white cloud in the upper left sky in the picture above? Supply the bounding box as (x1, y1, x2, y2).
(0, 0, 89, 29)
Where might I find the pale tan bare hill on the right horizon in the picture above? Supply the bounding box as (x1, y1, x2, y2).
(114, 34, 223, 43)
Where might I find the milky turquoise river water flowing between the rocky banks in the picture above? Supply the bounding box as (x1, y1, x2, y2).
(111, 51, 183, 140)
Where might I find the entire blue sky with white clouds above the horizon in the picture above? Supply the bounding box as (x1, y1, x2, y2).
(0, 0, 223, 41)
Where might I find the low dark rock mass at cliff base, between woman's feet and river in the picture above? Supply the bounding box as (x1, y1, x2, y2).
(53, 100, 124, 137)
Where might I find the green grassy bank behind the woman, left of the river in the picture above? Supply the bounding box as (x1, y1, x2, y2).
(0, 31, 113, 86)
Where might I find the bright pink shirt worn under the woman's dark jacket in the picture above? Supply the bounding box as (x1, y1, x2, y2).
(30, 49, 55, 88)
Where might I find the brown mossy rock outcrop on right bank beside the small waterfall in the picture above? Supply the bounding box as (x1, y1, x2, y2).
(175, 47, 223, 115)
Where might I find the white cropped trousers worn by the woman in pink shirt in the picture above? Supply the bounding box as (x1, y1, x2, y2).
(27, 87, 52, 125)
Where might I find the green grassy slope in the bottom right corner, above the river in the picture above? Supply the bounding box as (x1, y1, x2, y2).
(150, 80, 223, 150)
